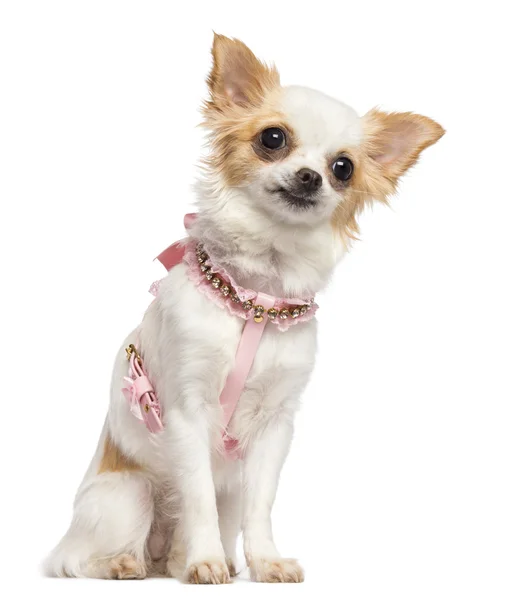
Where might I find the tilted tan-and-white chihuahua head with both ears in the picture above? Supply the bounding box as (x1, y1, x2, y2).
(200, 35, 444, 236)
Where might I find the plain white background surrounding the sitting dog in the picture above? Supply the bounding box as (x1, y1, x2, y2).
(0, 0, 506, 600)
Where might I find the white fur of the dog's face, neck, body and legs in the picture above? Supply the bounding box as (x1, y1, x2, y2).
(43, 88, 361, 582)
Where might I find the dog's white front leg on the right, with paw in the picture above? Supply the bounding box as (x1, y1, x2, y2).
(243, 419, 304, 583)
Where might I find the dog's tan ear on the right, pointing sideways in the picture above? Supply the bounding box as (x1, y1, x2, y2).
(362, 109, 445, 185)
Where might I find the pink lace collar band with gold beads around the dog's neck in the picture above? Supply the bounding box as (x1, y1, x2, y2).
(150, 240, 318, 331)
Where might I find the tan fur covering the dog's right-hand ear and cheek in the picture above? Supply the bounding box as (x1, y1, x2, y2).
(332, 109, 445, 239)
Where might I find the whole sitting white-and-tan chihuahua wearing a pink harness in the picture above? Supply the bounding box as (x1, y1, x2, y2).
(46, 35, 444, 583)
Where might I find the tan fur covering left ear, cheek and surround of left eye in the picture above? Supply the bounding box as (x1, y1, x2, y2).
(203, 35, 288, 186)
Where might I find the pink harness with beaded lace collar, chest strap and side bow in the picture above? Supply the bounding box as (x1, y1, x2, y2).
(122, 214, 318, 458)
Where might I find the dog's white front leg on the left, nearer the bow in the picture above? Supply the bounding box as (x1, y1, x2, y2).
(166, 408, 230, 583)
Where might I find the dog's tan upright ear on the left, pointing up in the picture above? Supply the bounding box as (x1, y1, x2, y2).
(207, 34, 279, 111)
